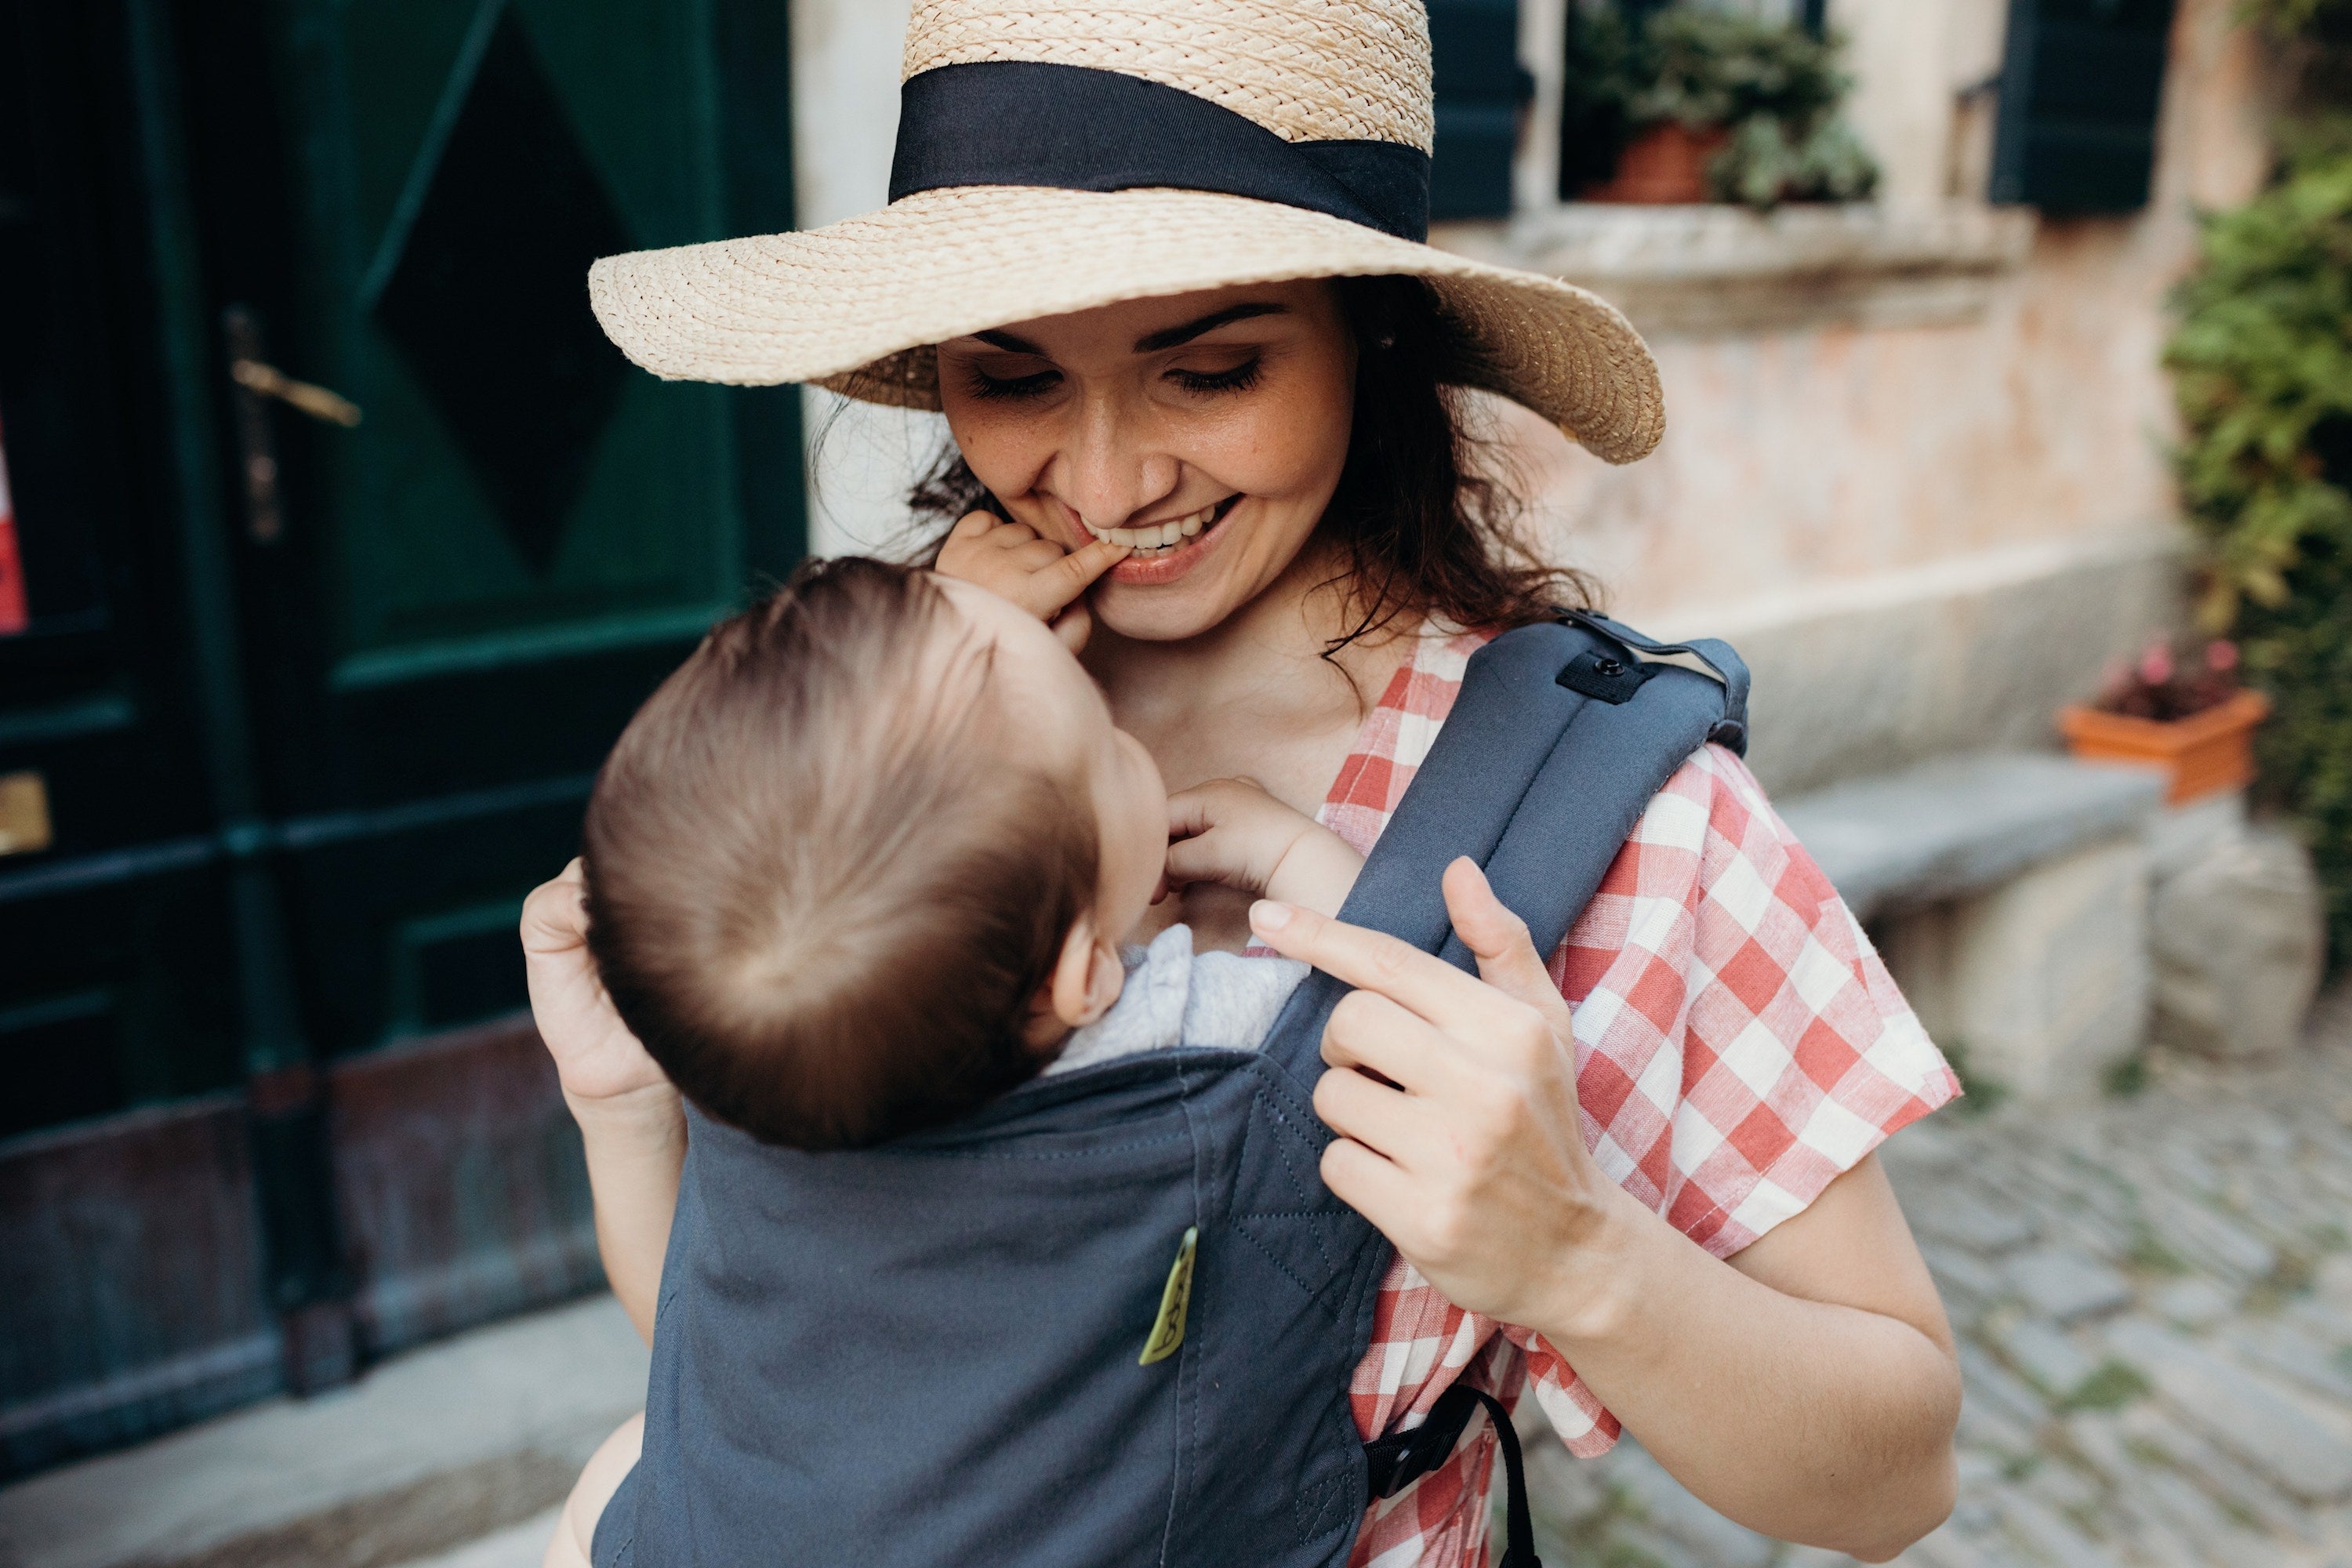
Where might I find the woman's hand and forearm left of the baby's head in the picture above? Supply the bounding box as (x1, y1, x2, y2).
(522, 860, 687, 1345)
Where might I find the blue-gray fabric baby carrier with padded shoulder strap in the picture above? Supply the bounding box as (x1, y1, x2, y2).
(595, 614, 1748, 1568)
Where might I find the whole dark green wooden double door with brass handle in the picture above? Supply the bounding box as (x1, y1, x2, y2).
(0, 0, 802, 1474)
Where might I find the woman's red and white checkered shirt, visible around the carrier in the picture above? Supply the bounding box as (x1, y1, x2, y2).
(1319, 633, 1959, 1568)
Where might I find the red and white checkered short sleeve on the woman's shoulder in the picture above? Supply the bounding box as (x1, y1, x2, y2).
(1503, 746, 1959, 1453)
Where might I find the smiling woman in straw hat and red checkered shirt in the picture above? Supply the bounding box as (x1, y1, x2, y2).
(550, 0, 1959, 1566)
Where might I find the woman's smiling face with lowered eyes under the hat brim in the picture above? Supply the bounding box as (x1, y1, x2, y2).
(938, 280, 1355, 642)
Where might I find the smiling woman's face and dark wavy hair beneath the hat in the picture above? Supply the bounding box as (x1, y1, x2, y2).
(910, 278, 1592, 647)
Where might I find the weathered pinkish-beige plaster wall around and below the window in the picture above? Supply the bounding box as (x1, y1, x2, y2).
(1491, 0, 2274, 789)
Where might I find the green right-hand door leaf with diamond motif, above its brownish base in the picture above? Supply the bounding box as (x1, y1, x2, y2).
(223, 0, 797, 1053)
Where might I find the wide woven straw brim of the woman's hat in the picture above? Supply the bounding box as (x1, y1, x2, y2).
(588, 186, 1665, 463)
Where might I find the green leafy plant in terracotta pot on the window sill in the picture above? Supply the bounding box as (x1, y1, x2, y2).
(1564, 7, 1879, 209)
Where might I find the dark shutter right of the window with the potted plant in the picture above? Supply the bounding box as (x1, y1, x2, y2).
(1990, 0, 2173, 212)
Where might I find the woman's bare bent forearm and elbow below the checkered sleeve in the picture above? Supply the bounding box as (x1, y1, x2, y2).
(1543, 1171, 1959, 1561)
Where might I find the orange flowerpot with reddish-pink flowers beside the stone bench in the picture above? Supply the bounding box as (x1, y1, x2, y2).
(2058, 640, 2270, 806)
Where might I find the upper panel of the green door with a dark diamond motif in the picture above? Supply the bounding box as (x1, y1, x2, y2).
(287, 0, 743, 761)
